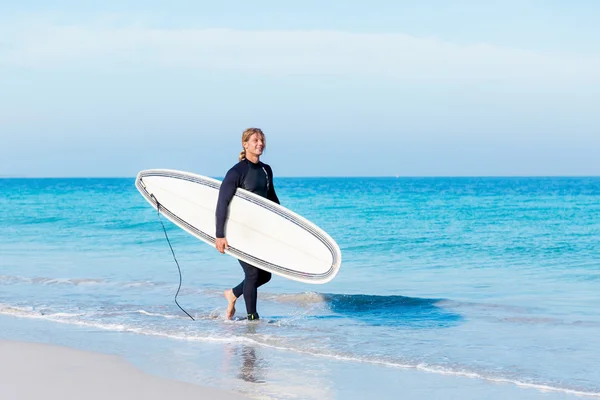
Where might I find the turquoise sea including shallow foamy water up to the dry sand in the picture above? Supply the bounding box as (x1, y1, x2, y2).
(0, 177, 600, 399)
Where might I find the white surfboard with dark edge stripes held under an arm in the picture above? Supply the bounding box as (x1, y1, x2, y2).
(135, 169, 342, 284)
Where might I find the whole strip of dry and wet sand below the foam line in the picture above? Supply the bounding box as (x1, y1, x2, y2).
(0, 316, 599, 400)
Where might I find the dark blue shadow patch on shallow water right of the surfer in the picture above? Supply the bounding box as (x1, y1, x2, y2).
(315, 294, 463, 329)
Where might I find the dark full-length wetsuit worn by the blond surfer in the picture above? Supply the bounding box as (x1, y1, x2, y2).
(216, 159, 279, 319)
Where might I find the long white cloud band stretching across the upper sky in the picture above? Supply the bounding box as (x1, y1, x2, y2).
(0, 17, 600, 83)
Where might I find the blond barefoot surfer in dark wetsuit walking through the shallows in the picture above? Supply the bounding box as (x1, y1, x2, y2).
(215, 128, 279, 320)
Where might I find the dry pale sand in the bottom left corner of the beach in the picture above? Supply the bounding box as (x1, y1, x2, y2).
(0, 339, 248, 400)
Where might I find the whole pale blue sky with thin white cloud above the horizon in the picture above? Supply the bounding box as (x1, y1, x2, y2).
(0, 0, 600, 177)
